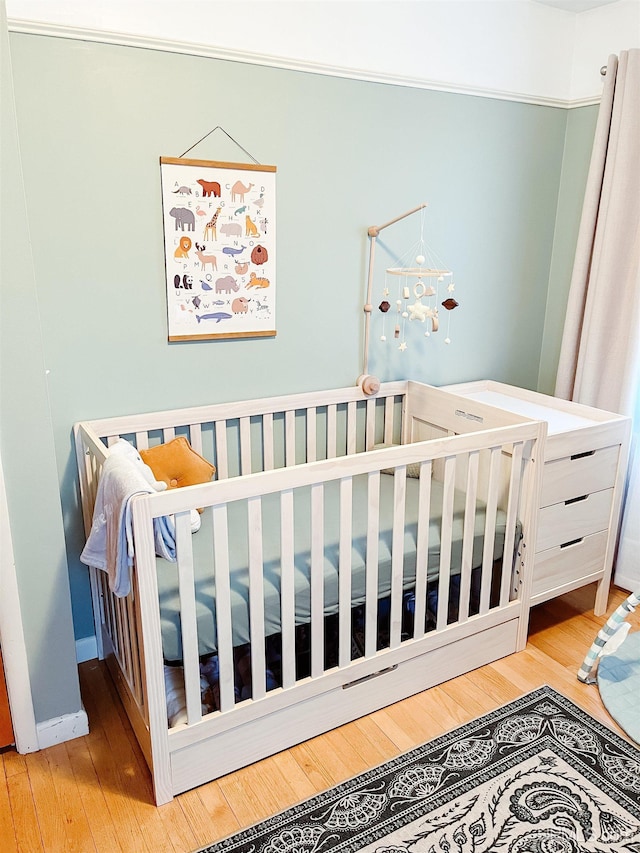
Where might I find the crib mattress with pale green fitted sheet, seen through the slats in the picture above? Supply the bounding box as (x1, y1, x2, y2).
(157, 474, 506, 661)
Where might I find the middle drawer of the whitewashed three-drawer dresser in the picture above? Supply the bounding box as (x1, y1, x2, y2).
(536, 489, 613, 552)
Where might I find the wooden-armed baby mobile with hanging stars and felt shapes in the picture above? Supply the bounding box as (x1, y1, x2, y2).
(358, 204, 459, 394)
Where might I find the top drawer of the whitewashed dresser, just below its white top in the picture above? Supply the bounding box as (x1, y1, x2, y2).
(540, 444, 620, 506)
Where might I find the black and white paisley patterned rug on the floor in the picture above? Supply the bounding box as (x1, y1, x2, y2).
(195, 687, 640, 853)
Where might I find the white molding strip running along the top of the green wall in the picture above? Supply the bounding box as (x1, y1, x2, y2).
(7, 18, 600, 109)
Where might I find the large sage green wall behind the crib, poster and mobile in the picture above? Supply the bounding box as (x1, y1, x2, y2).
(11, 34, 580, 637)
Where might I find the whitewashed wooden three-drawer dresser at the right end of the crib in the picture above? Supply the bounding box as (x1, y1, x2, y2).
(446, 380, 631, 615)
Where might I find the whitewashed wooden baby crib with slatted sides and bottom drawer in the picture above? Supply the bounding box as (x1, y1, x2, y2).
(74, 382, 546, 804)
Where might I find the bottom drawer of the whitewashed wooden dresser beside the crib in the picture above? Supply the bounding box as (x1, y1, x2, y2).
(531, 530, 609, 603)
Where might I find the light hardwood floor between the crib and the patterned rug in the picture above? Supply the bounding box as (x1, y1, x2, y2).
(0, 587, 640, 853)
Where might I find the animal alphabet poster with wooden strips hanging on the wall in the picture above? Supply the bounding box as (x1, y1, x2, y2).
(160, 157, 276, 341)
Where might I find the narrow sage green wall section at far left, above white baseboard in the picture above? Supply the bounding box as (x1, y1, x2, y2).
(0, 2, 81, 723)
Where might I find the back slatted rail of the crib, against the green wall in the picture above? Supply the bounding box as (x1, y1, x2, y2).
(86, 382, 407, 480)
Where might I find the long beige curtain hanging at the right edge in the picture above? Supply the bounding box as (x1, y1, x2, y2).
(555, 49, 640, 588)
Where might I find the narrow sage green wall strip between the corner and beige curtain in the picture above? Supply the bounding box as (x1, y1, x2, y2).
(538, 106, 598, 394)
